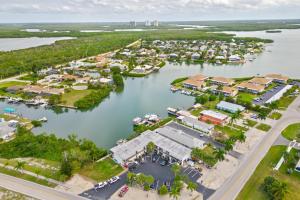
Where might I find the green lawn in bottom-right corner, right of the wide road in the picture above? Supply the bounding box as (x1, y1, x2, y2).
(236, 146, 300, 200)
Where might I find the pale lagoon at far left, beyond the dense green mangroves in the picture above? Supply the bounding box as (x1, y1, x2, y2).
(0, 37, 74, 51)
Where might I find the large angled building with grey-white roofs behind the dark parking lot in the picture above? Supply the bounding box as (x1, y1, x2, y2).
(110, 126, 206, 165)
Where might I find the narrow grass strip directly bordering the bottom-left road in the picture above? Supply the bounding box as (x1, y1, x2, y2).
(0, 167, 56, 188)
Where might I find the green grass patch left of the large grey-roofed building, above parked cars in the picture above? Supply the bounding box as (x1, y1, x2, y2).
(79, 158, 123, 182)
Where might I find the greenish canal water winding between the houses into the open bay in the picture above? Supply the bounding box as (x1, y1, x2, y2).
(0, 30, 300, 148)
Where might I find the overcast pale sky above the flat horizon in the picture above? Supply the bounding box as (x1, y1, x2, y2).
(0, 0, 300, 23)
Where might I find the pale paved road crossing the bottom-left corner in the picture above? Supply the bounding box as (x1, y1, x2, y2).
(0, 173, 86, 200)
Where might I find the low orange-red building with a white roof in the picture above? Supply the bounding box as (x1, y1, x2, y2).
(199, 110, 228, 125)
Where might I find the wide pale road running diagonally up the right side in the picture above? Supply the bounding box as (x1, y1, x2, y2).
(210, 96, 300, 200)
